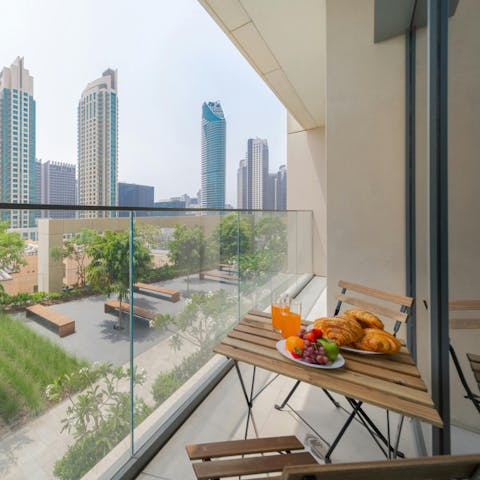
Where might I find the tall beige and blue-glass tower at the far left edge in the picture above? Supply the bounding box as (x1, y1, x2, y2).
(0, 57, 37, 228)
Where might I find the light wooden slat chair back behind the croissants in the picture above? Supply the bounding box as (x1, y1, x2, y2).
(335, 280, 414, 336)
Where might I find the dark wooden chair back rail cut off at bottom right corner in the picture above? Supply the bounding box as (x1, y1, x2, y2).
(281, 454, 480, 480)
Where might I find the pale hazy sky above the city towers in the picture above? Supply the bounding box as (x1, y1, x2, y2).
(0, 0, 286, 206)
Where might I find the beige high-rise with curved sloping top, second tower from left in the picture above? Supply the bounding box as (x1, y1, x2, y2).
(78, 69, 118, 217)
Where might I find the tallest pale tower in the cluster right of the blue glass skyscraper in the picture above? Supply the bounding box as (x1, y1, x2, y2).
(247, 138, 268, 209)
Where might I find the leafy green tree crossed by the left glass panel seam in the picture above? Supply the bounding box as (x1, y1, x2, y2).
(86, 230, 152, 328)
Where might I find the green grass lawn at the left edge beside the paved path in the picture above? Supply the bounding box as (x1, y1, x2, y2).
(0, 313, 87, 423)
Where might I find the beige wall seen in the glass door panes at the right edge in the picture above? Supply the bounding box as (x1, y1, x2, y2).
(416, 0, 480, 431)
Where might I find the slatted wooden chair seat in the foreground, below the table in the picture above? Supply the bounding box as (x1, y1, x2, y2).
(185, 436, 316, 480)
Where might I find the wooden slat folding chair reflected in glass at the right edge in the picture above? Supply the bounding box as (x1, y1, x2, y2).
(449, 300, 480, 413)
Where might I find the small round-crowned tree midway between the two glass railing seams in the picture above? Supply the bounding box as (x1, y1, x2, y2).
(168, 224, 206, 295)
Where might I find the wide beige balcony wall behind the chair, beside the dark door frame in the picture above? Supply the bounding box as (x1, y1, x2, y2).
(326, 0, 405, 312)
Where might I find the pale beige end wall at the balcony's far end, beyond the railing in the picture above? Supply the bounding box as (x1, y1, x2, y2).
(287, 115, 327, 275)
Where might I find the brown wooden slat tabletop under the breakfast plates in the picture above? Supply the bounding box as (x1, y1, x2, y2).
(214, 311, 443, 427)
